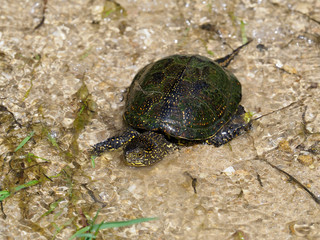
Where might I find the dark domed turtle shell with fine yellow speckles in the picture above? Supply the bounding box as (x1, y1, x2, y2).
(124, 55, 241, 140)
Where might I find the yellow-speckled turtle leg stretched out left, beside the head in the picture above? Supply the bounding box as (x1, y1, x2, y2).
(91, 128, 140, 156)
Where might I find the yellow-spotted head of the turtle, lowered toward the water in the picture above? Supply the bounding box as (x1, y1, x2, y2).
(124, 132, 176, 167)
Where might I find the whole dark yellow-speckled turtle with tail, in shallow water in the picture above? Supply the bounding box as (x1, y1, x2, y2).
(92, 40, 252, 167)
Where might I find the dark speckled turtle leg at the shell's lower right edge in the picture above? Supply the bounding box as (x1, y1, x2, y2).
(206, 105, 252, 147)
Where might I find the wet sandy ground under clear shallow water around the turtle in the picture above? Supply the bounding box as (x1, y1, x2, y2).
(0, 0, 320, 239)
